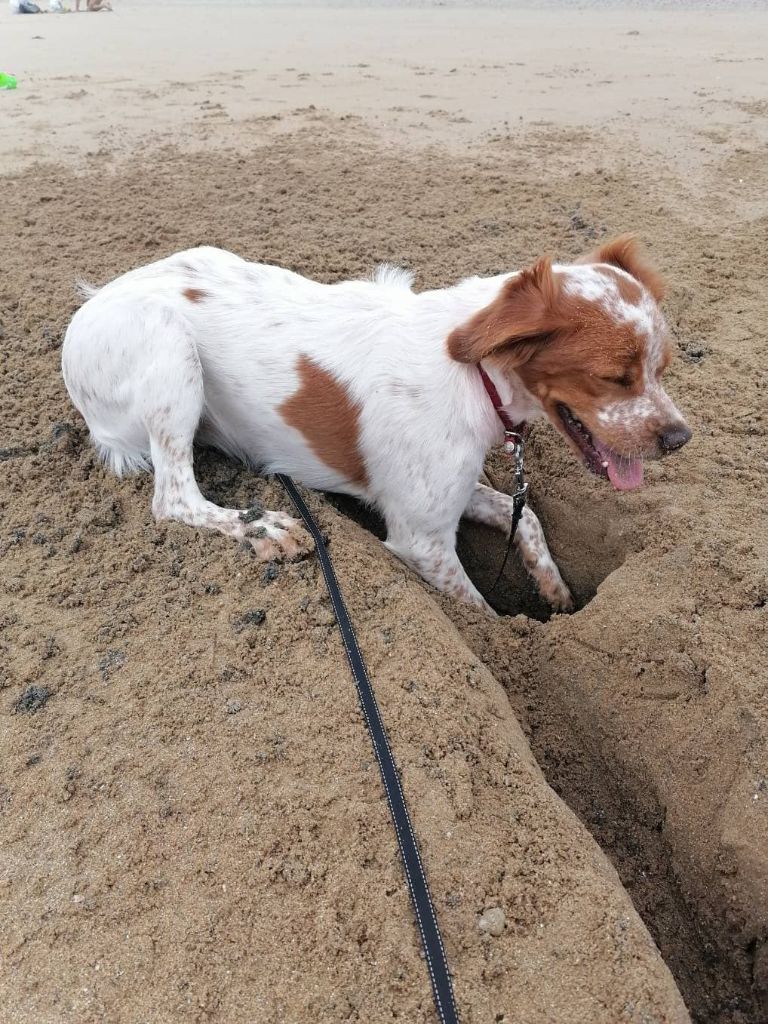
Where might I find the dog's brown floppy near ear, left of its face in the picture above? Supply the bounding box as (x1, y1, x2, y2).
(447, 257, 564, 364)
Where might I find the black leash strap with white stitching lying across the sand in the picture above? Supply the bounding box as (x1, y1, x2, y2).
(276, 473, 459, 1024)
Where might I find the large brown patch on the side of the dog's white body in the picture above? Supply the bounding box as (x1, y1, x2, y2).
(278, 355, 368, 486)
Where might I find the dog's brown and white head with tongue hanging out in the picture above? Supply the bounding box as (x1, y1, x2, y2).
(449, 236, 691, 490)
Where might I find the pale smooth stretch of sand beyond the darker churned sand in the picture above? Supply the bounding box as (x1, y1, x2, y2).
(0, 0, 768, 175)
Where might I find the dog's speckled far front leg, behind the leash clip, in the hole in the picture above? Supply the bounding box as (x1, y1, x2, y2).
(464, 483, 573, 611)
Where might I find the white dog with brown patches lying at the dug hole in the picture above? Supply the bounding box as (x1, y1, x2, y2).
(62, 236, 691, 611)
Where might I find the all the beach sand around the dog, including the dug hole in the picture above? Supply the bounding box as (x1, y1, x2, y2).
(0, 2, 768, 1024)
